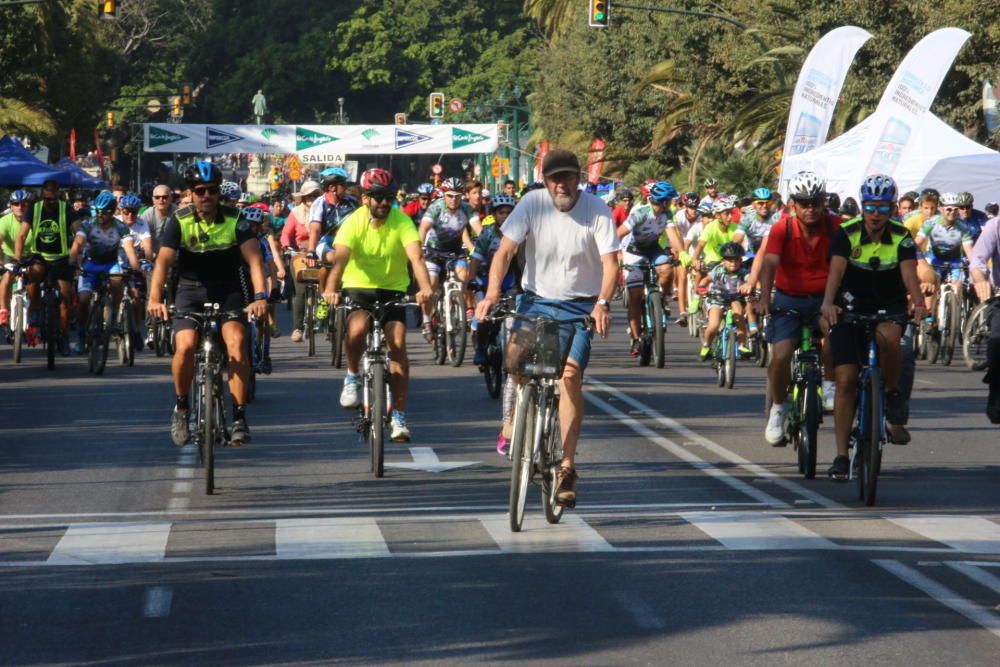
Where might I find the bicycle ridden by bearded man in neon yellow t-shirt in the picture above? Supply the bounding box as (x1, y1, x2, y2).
(347, 296, 412, 477)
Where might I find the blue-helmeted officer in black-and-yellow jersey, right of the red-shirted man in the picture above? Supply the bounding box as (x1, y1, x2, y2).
(821, 174, 925, 481)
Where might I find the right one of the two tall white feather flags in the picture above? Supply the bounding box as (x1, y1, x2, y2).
(851, 28, 972, 179)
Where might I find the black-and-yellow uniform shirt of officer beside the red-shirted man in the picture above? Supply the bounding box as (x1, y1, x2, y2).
(830, 222, 917, 312)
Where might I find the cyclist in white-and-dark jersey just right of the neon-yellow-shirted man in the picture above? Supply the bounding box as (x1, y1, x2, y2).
(420, 178, 483, 342)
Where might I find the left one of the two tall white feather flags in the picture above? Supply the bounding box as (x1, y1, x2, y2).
(781, 26, 871, 175)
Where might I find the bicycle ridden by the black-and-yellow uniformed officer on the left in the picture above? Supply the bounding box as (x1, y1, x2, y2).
(172, 303, 243, 495)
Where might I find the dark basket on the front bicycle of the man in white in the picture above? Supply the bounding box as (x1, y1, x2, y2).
(505, 318, 576, 379)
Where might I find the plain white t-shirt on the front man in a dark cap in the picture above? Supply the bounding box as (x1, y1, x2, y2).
(501, 190, 619, 299)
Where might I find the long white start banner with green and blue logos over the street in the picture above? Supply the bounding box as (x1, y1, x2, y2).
(144, 123, 499, 154)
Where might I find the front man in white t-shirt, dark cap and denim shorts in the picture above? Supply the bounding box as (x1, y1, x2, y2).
(477, 150, 619, 507)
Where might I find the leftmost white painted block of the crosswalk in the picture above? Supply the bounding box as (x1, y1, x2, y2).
(48, 521, 170, 565)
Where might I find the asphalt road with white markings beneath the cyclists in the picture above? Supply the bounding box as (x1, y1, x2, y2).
(0, 312, 1000, 667)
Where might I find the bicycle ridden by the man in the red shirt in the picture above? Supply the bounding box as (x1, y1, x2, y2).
(767, 309, 823, 479)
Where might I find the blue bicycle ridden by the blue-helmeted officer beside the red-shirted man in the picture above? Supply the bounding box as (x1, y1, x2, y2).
(840, 310, 907, 507)
